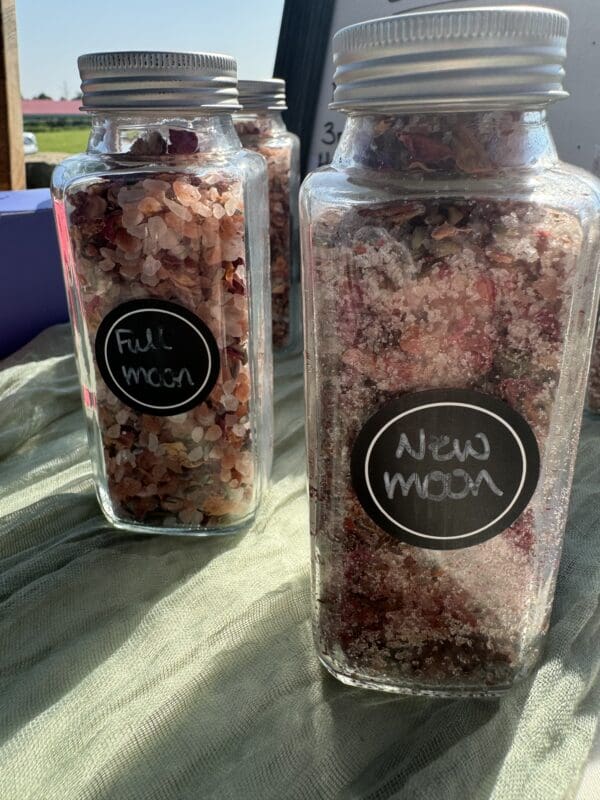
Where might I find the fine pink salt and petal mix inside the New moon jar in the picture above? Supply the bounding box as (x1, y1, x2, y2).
(309, 197, 582, 689)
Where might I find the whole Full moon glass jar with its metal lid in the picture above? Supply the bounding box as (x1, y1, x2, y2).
(52, 53, 272, 535)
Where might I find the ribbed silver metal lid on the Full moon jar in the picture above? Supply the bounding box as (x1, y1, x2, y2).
(77, 51, 240, 112)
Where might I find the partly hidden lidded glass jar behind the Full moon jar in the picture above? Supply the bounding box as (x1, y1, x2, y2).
(234, 78, 301, 353)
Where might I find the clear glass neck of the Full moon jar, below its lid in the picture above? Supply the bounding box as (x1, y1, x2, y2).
(87, 112, 241, 158)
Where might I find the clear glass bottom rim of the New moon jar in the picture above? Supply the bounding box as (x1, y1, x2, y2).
(319, 654, 533, 699)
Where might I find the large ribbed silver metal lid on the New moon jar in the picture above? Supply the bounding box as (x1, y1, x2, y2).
(330, 6, 569, 111)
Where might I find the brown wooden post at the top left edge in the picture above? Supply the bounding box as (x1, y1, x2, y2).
(0, 0, 25, 190)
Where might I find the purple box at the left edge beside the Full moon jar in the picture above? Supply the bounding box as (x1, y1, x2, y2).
(0, 189, 68, 358)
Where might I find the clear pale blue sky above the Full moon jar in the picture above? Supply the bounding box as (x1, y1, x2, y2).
(16, 0, 283, 98)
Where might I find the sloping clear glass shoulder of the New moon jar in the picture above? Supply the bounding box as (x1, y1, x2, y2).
(300, 162, 600, 221)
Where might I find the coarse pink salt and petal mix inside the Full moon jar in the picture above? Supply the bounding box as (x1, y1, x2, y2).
(59, 157, 254, 527)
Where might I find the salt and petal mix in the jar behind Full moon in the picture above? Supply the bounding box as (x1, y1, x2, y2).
(235, 118, 293, 349)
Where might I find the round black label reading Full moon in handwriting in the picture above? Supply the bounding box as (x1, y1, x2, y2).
(95, 299, 220, 417)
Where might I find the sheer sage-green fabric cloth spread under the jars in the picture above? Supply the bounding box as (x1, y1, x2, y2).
(0, 327, 600, 800)
